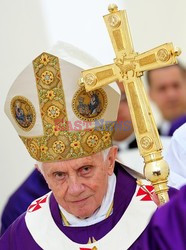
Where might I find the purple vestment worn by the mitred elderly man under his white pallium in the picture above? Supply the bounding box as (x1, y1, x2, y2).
(0, 163, 180, 250)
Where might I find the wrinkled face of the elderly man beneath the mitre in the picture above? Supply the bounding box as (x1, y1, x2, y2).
(40, 147, 117, 218)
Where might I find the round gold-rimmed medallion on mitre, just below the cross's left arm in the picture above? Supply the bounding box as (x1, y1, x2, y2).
(72, 87, 108, 121)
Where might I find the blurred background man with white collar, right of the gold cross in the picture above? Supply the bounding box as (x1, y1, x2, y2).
(147, 63, 186, 136)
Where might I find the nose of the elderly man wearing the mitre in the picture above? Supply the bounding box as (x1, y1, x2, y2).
(68, 176, 85, 196)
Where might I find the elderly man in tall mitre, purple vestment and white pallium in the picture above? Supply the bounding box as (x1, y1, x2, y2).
(0, 47, 176, 250)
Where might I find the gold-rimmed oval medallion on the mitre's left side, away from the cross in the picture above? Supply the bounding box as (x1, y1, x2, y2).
(10, 96, 36, 131)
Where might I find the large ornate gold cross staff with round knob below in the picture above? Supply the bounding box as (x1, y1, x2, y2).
(80, 4, 180, 204)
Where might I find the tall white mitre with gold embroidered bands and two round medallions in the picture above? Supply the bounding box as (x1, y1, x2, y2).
(5, 42, 120, 162)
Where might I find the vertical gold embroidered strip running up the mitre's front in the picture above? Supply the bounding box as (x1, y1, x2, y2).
(33, 53, 68, 135)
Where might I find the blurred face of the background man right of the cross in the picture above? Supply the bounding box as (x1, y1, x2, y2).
(149, 66, 186, 121)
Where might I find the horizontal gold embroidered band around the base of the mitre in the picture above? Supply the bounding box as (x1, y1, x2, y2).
(20, 129, 113, 162)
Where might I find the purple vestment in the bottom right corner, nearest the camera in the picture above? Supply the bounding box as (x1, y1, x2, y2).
(142, 185, 186, 250)
